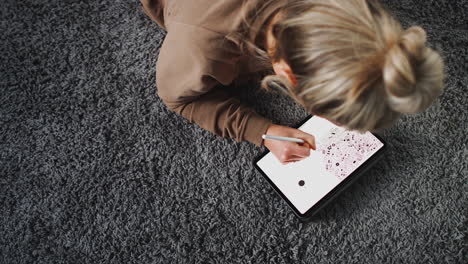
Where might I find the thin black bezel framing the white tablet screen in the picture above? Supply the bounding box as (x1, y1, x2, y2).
(253, 115, 387, 220)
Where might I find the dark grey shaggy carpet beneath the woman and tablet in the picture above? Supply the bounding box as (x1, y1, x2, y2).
(0, 0, 468, 263)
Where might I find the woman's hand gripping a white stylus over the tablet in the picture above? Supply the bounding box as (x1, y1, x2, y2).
(263, 124, 316, 165)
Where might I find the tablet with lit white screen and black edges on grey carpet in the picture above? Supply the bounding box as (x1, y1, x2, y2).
(254, 115, 386, 220)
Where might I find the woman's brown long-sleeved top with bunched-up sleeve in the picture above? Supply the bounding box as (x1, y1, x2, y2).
(141, 0, 272, 146)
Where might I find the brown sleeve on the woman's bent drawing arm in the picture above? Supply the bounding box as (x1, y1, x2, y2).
(156, 22, 272, 146)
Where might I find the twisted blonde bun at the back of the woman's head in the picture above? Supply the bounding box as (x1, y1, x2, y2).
(383, 26, 443, 113)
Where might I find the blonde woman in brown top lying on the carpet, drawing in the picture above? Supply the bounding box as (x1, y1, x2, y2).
(142, 0, 444, 164)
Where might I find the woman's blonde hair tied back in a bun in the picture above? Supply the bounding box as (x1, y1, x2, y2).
(232, 0, 444, 132)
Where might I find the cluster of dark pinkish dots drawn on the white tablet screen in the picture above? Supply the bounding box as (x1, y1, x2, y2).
(317, 127, 381, 180)
